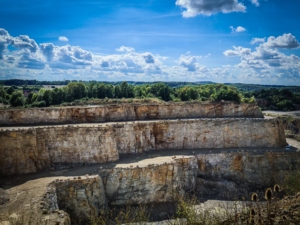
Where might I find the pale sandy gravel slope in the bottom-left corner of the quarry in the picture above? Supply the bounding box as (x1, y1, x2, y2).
(0, 178, 70, 225)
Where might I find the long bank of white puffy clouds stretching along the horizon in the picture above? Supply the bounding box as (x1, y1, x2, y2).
(0, 29, 300, 84)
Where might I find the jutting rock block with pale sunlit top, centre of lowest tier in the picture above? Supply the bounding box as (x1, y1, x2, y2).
(100, 156, 197, 205)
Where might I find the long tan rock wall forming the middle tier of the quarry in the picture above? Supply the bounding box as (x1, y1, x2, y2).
(0, 118, 286, 176)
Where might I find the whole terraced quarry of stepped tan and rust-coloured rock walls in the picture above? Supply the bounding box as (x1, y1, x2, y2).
(0, 102, 300, 225)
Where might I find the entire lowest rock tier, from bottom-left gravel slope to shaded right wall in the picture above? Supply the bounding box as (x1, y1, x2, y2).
(0, 151, 300, 225)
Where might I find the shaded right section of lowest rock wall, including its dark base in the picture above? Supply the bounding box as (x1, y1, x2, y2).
(197, 152, 300, 200)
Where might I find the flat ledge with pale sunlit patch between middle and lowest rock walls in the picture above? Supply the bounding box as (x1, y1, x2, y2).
(0, 138, 300, 189)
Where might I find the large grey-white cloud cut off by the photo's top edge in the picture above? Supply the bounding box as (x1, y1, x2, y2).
(176, 0, 246, 17)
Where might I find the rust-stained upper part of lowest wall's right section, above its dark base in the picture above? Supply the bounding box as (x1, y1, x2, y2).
(197, 151, 300, 187)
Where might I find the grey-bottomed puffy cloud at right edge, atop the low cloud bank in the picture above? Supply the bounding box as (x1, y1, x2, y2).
(264, 33, 300, 49)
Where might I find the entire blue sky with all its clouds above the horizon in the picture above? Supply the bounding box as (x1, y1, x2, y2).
(0, 0, 300, 85)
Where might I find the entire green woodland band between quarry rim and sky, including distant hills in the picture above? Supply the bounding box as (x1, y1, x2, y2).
(0, 80, 300, 111)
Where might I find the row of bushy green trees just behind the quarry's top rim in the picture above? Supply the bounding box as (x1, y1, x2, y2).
(0, 81, 255, 107)
